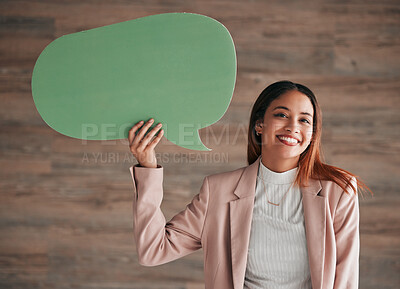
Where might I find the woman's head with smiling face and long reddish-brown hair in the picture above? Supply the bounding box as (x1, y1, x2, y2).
(247, 81, 369, 193)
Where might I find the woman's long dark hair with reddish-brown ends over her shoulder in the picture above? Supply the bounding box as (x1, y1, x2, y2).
(247, 80, 373, 195)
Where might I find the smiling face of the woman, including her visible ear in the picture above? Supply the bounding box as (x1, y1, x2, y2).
(256, 90, 314, 160)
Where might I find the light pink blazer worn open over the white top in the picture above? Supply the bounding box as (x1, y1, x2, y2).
(129, 158, 360, 289)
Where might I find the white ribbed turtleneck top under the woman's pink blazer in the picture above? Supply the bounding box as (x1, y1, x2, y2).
(244, 161, 312, 289)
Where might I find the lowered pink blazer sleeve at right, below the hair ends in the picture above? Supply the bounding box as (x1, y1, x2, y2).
(333, 177, 360, 289)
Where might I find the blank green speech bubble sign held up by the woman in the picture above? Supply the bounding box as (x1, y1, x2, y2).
(32, 13, 236, 150)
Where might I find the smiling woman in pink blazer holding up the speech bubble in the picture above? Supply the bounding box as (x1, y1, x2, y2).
(129, 81, 368, 289)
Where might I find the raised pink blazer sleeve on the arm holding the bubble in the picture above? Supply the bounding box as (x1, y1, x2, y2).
(130, 166, 209, 266)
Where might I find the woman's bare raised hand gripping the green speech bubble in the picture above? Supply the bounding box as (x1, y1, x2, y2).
(128, 118, 164, 168)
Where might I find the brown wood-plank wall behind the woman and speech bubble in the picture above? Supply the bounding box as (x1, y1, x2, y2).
(0, 0, 400, 289)
